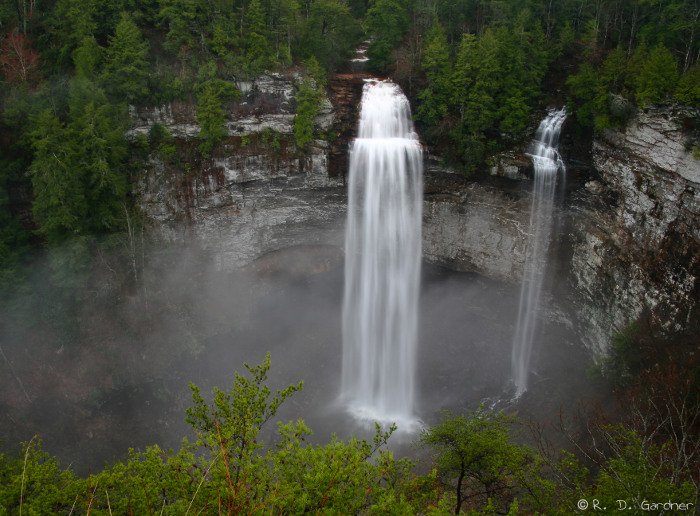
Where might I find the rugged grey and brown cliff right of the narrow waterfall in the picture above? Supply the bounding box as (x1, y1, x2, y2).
(571, 108, 700, 354)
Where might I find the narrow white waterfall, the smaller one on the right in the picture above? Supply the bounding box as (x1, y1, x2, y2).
(512, 108, 566, 397)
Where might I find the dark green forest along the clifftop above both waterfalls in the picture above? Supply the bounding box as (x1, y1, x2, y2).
(0, 0, 700, 282)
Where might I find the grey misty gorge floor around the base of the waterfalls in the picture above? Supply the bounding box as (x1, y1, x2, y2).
(0, 249, 591, 472)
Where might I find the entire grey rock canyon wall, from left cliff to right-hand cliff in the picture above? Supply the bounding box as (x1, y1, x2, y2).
(132, 73, 700, 355)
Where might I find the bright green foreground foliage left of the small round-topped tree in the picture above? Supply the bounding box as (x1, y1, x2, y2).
(0, 355, 430, 514)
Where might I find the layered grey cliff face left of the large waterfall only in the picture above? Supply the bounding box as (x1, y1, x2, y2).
(132, 74, 345, 269)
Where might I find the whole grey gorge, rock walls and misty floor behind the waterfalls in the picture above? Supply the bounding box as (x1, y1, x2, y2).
(0, 68, 698, 476)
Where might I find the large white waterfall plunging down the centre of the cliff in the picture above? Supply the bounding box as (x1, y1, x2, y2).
(342, 80, 423, 429)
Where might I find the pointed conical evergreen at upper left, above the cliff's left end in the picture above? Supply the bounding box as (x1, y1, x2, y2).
(102, 13, 149, 103)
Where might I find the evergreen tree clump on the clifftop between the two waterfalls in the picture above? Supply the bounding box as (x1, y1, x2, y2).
(417, 13, 549, 173)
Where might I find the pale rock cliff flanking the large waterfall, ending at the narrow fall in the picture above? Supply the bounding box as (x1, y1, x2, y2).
(132, 73, 529, 282)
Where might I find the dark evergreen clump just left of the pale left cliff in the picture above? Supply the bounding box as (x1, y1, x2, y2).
(30, 79, 126, 243)
